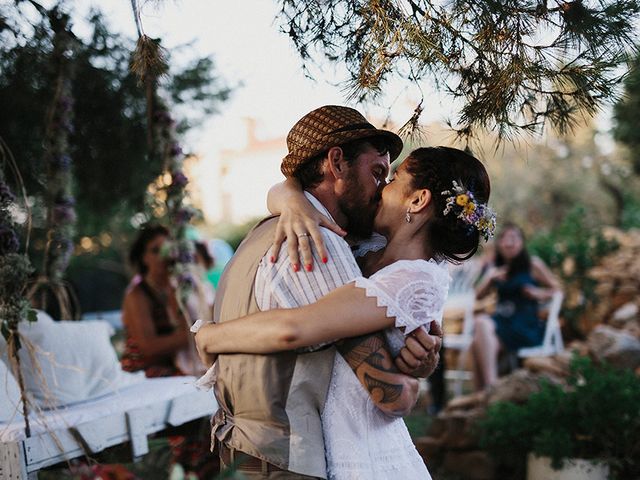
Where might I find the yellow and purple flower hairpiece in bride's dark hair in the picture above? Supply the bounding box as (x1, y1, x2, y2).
(442, 180, 496, 241)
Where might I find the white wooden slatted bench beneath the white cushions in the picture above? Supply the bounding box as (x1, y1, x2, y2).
(0, 377, 218, 480)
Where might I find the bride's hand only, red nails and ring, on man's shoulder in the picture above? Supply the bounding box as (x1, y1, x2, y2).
(270, 182, 347, 272)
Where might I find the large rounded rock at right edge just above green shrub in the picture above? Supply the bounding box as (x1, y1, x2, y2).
(587, 325, 640, 370)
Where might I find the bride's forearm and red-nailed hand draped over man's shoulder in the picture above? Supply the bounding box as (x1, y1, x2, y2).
(267, 178, 347, 269)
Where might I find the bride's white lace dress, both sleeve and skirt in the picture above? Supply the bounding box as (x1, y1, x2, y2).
(322, 260, 449, 480)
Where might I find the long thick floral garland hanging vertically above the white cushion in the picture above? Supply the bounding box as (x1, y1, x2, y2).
(29, 11, 78, 319)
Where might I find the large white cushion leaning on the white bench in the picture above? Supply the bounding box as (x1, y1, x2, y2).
(0, 312, 144, 409)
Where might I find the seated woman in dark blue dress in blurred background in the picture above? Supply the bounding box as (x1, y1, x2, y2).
(471, 224, 561, 390)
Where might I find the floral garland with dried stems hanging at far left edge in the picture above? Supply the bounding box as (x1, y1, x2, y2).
(0, 139, 37, 437)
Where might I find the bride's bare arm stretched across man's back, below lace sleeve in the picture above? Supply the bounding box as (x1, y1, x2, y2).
(196, 283, 394, 354)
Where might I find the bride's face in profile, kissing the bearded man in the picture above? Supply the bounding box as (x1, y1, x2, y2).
(374, 162, 413, 235)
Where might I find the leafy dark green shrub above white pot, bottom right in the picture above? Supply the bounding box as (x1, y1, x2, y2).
(479, 356, 640, 480)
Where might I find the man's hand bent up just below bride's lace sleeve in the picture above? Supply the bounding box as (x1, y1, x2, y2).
(395, 322, 442, 378)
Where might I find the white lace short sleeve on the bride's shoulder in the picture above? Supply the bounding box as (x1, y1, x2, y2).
(355, 260, 450, 335)
